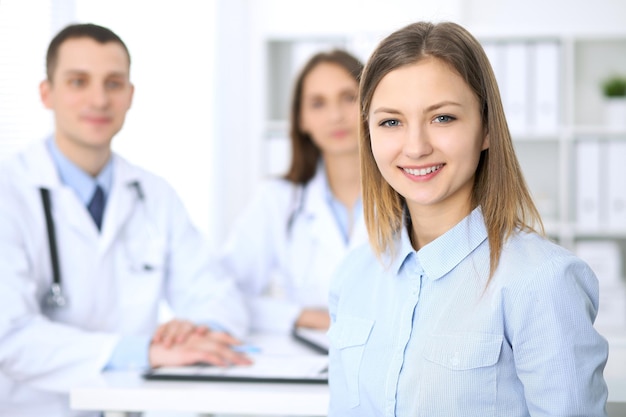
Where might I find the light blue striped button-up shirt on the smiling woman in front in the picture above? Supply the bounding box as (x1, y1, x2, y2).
(329, 209, 608, 417)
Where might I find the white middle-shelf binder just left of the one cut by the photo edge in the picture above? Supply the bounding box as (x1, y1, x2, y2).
(575, 140, 601, 230)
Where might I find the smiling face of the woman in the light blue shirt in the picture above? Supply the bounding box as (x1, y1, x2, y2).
(368, 58, 489, 218)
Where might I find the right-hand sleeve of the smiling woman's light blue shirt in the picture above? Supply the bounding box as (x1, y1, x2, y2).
(506, 256, 608, 417)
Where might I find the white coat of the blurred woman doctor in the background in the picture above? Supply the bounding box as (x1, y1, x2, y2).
(220, 165, 367, 333)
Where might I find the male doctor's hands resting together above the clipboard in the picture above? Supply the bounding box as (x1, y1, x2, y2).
(149, 330, 252, 368)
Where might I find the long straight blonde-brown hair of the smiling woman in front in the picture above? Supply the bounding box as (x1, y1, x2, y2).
(359, 22, 544, 277)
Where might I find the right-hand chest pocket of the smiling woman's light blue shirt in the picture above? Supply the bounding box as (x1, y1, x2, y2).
(419, 333, 503, 417)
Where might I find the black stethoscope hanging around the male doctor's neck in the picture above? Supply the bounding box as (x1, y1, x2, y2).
(39, 181, 144, 309)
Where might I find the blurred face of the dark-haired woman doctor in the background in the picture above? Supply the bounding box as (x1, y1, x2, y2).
(300, 62, 359, 157)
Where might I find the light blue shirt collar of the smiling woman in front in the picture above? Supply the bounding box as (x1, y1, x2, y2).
(391, 207, 487, 280)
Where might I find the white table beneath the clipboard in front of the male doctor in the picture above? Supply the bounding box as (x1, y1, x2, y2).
(70, 373, 329, 416)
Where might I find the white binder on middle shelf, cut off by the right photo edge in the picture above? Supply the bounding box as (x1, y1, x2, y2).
(605, 140, 626, 231)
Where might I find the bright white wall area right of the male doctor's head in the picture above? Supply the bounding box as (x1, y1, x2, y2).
(75, 0, 216, 236)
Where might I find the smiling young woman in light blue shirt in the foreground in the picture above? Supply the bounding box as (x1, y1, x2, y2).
(329, 22, 608, 417)
